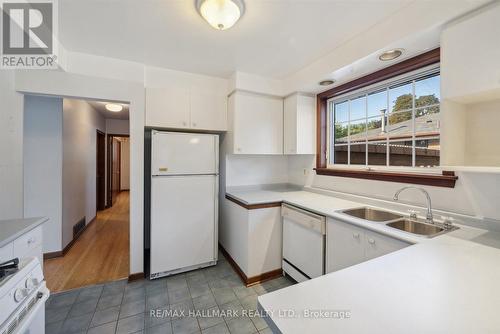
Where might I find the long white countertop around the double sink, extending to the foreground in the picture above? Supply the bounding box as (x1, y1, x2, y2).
(227, 187, 500, 334)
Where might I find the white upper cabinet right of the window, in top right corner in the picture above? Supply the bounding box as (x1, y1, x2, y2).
(441, 3, 500, 103)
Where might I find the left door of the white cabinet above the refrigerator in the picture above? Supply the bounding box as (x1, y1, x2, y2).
(146, 87, 190, 129)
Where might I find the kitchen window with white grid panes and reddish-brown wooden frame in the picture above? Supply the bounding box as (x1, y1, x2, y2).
(316, 49, 457, 187)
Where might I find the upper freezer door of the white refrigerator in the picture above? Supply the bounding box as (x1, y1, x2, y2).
(151, 131, 219, 175)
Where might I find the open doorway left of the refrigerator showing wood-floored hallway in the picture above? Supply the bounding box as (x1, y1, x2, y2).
(23, 95, 130, 292)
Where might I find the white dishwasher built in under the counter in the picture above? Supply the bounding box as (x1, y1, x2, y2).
(281, 204, 326, 282)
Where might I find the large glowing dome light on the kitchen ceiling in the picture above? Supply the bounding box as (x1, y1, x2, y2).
(196, 0, 245, 30)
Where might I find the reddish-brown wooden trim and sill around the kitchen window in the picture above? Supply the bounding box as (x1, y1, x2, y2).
(316, 48, 458, 188)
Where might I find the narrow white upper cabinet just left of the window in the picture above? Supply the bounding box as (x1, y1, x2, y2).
(283, 94, 316, 154)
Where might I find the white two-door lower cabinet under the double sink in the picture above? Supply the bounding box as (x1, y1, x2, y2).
(326, 218, 410, 273)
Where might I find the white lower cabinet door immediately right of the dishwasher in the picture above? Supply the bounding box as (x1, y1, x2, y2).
(326, 219, 365, 273)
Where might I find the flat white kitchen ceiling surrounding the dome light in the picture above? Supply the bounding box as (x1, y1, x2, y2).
(59, 0, 412, 78)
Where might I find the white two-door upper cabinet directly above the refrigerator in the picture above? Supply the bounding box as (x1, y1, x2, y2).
(146, 87, 227, 131)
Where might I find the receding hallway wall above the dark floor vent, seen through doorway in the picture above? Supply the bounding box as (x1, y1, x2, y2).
(62, 99, 106, 247)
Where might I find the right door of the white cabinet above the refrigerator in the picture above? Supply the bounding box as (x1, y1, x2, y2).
(191, 92, 227, 131)
